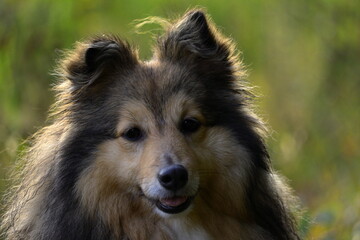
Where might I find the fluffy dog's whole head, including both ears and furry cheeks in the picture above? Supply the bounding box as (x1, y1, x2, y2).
(59, 11, 268, 221)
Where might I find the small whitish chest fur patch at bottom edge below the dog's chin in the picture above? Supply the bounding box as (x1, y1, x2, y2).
(163, 219, 212, 240)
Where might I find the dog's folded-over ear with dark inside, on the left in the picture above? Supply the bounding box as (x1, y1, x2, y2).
(60, 36, 137, 88)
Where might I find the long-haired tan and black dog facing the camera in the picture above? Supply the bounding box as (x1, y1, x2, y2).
(2, 9, 300, 240)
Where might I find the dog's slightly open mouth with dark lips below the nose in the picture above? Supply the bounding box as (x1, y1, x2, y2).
(155, 196, 193, 214)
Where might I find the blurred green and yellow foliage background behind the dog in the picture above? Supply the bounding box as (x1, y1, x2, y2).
(0, 0, 360, 240)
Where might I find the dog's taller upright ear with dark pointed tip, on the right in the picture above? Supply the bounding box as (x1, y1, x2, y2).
(155, 10, 238, 79)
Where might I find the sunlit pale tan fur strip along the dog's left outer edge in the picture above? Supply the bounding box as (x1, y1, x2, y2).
(2, 124, 71, 240)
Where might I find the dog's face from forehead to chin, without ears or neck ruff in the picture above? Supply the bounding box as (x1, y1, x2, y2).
(97, 61, 253, 218)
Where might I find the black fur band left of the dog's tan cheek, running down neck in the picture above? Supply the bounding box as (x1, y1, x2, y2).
(34, 130, 111, 240)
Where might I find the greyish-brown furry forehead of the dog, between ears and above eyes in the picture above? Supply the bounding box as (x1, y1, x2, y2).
(119, 61, 204, 123)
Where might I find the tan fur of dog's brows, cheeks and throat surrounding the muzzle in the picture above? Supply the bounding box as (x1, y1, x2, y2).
(72, 90, 262, 239)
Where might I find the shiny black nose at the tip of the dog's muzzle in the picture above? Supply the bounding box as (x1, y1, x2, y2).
(158, 164, 188, 191)
